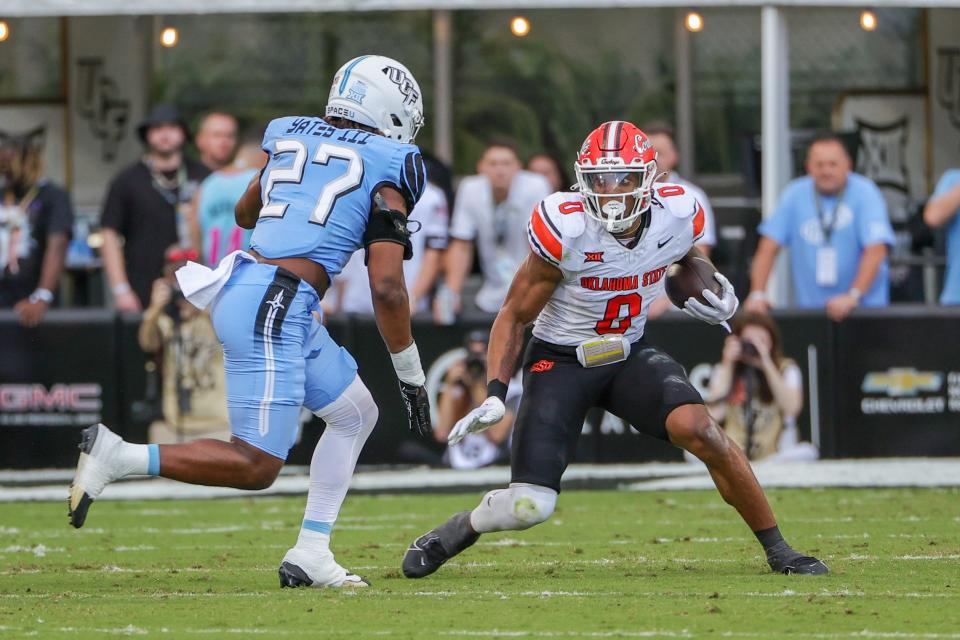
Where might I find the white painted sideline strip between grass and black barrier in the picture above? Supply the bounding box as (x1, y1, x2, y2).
(0, 458, 960, 502)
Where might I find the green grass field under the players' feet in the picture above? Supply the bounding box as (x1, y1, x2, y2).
(0, 489, 960, 638)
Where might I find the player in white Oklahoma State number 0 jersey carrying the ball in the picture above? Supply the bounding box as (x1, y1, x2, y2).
(403, 121, 827, 578)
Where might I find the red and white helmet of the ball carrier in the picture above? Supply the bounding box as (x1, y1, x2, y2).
(574, 120, 657, 233)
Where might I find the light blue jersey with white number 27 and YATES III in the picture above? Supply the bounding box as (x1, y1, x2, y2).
(250, 116, 427, 278)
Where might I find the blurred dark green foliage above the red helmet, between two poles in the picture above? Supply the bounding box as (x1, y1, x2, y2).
(454, 11, 673, 175)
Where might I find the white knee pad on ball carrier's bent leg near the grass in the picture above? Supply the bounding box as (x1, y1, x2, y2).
(470, 484, 557, 533)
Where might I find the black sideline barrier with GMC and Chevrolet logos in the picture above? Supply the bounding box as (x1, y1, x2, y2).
(0, 306, 960, 468)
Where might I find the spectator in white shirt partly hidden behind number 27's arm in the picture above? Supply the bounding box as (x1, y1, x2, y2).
(324, 182, 449, 316)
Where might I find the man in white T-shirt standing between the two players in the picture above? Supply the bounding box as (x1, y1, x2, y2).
(438, 140, 550, 316)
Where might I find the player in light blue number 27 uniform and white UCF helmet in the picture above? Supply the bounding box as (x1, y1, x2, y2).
(70, 56, 432, 587)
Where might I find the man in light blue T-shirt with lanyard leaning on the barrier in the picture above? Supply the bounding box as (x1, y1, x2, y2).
(745, 134, 894, 321)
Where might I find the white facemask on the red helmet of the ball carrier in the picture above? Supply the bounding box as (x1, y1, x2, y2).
(574, 160, 657, 233)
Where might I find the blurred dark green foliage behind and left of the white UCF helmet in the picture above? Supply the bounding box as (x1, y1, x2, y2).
(151, 12, 433, 142)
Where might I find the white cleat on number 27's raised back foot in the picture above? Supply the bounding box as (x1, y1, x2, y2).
(69, 424, 126, 529)
